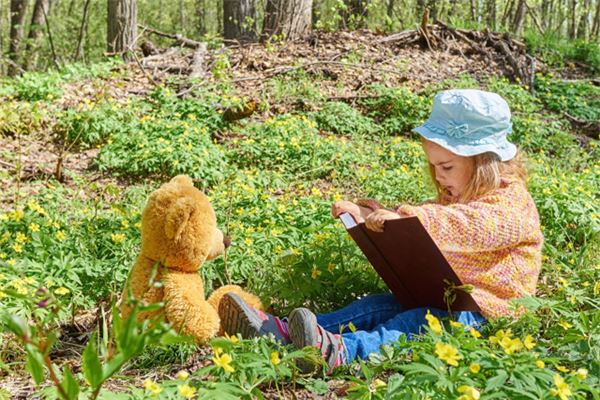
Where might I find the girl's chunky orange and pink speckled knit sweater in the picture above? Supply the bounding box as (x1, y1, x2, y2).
(396, 179, 543, 318)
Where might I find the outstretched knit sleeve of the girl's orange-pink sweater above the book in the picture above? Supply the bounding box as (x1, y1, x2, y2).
(396, 183, 539, 252)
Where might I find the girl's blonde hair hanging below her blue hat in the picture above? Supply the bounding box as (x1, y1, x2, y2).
(429, 152, 527, 204)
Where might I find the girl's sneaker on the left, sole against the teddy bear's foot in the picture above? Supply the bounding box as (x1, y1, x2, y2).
(219, 293, 291, 344)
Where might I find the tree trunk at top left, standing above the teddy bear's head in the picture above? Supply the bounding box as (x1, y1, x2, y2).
(107, 0, 137, 61)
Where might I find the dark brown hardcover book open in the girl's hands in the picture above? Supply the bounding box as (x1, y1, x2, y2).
(340, 213, 480, 311)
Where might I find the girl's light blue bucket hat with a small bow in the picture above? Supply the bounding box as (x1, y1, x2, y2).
(413, 89, 517, 161)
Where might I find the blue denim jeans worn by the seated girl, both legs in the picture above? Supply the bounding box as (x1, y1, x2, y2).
(317, 293, 485, 362)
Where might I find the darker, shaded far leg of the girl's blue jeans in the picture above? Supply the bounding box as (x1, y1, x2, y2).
(317, 293, 405, 333)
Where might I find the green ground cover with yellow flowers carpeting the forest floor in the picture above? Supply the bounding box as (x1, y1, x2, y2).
(0, 38, 600, 400)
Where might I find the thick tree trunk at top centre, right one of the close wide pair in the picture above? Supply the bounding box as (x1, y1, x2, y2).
(263, 0, 312, 40)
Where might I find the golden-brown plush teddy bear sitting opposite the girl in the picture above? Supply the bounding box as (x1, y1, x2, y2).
(120, 175, 262, 343)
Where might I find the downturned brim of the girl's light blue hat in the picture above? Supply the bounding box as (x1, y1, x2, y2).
(413, 125, 517, 161)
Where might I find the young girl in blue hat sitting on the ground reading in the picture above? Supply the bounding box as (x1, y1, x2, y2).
(219, 90, 543, 368)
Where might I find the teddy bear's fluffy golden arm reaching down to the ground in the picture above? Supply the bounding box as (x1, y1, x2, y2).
(163, 271, 220, 343)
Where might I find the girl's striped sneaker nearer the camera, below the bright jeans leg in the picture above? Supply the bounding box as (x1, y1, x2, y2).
(288, 308, 346, 373)
